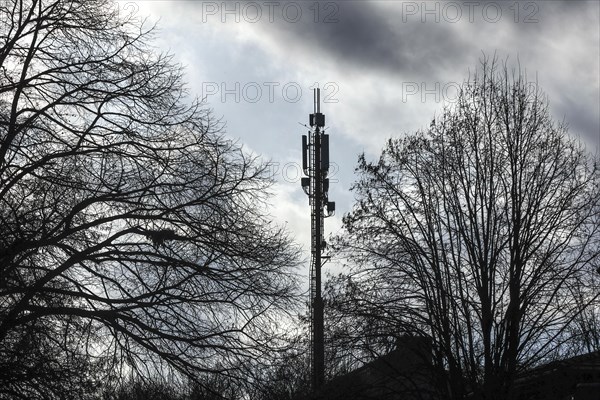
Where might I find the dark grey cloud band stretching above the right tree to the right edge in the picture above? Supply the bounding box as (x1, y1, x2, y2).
(190, 0, 600, 146)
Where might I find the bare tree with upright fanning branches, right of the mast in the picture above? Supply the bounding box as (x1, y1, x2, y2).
(333, 59, 600, 399)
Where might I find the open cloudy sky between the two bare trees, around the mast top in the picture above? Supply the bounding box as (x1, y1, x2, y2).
(121, 0, 600, 288)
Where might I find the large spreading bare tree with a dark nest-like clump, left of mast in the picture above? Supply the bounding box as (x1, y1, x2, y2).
(0, 0, 298, 398)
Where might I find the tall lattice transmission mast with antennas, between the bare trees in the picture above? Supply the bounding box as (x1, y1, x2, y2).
(301, 88, 335, 392)
